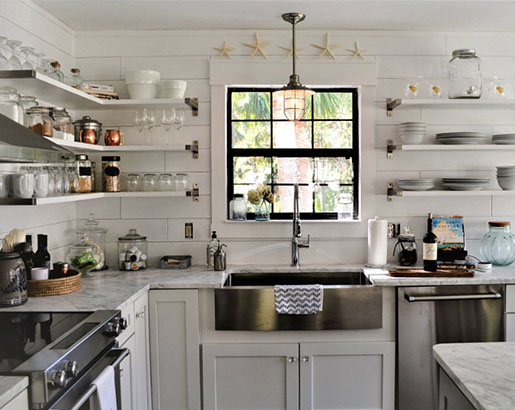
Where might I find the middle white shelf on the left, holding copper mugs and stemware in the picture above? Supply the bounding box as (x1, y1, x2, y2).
(45, 137, 199, 159)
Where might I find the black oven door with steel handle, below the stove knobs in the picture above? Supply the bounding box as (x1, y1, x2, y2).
(48, 348, 130, 410)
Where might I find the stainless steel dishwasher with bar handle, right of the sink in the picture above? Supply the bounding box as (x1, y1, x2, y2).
(396, 285, 505, 410)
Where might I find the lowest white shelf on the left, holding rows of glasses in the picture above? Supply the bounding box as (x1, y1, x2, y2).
(0, 184, 200, 205)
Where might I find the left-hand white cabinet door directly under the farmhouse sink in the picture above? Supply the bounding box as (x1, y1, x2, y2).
(202, 343, 299, 410)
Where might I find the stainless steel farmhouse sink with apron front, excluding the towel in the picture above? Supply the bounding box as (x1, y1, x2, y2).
(215, 271, 383, 331)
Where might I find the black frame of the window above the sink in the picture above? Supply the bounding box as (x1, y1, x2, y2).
(226, 87, 361, 220)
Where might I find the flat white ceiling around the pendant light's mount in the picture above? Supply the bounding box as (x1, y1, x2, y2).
(33, 0, 515, 32)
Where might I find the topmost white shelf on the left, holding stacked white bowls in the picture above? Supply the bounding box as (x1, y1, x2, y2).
(0, 70, 198, 117)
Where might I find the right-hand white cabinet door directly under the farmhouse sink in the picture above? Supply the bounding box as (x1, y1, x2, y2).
(300, 342, 395, 410)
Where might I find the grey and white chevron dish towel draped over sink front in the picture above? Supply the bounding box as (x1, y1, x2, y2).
(274, 285, 324, 315)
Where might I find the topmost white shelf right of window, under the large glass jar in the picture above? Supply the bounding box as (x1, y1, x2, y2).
(386, 97, 515, 117)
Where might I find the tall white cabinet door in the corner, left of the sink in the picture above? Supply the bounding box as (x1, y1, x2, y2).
(149, 290, 200, 410)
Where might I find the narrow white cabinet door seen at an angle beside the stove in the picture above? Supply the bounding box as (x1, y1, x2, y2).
(133, 294, 152, 410)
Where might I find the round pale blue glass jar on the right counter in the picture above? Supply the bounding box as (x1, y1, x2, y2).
(479, 222, 515, 266)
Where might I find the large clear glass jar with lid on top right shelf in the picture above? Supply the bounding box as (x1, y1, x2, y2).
(449, 48, 482, 98)
